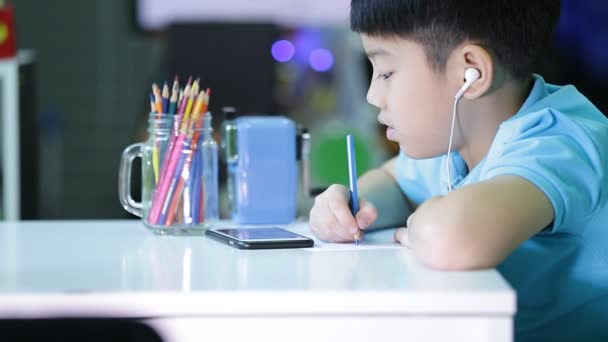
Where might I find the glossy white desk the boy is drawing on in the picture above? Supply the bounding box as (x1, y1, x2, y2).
(0, 221, 515, 342)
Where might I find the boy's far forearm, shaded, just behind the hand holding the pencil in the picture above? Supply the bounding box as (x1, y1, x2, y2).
(358, 157, 412, 230)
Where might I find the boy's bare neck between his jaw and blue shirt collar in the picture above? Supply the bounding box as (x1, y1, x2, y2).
(457, 77, 533, 170)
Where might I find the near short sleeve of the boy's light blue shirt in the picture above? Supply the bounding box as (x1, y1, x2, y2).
(483, 110, 608, 233)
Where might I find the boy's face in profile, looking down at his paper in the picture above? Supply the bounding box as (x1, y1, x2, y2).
(361, 35, 461, 159)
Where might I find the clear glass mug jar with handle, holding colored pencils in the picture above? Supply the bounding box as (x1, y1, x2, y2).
(118, 113, 218, 235)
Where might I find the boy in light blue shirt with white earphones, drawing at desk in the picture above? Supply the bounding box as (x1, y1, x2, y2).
(310, 0, 608, 341)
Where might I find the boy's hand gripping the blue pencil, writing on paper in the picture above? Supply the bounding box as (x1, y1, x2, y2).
(309, 184, 378, 242)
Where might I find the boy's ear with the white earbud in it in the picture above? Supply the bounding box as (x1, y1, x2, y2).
(456, 44, 494, 100)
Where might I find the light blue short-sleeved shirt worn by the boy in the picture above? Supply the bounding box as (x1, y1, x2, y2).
(395, 75, 608, 341)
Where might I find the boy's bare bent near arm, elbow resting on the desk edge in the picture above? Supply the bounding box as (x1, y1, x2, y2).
(397, 176, 554, 270)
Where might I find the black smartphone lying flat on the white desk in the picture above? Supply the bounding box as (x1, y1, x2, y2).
(205, 227, 315, 249)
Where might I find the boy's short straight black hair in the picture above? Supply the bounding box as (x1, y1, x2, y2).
(350, 0, 561, 79)
